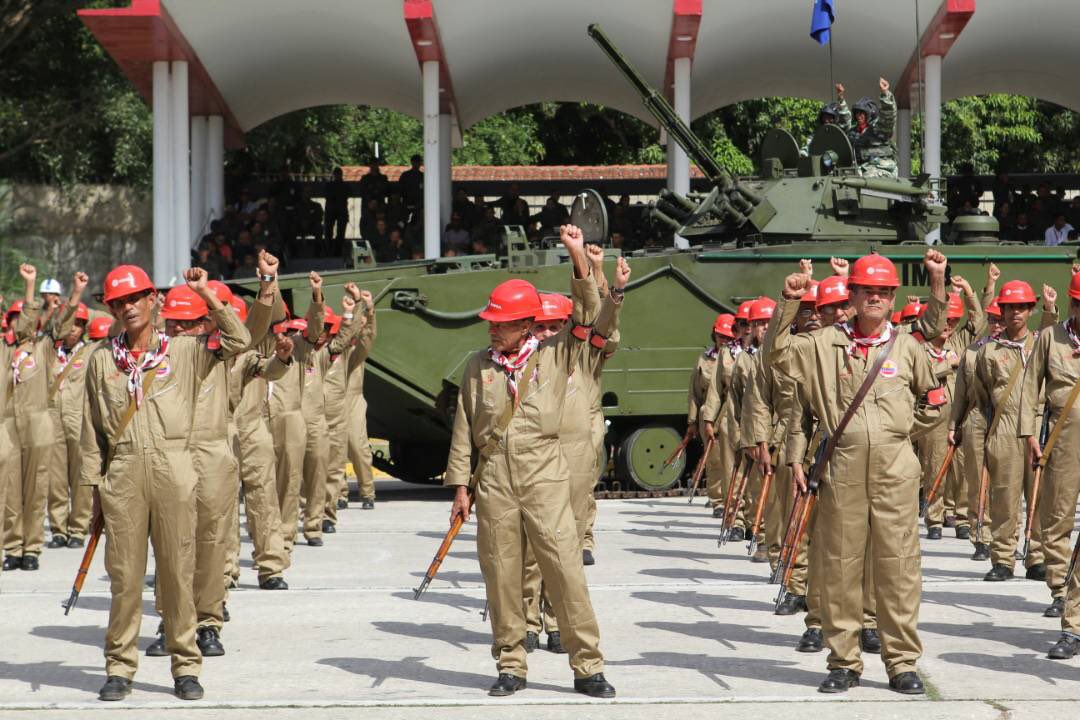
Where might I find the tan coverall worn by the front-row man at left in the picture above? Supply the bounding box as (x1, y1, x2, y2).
(81, 308, 251, 679)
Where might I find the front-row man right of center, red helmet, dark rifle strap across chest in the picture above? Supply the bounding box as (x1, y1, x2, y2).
(771, 249, 946, 694)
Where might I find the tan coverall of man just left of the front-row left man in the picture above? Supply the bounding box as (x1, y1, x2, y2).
(46, 340, 98, 540)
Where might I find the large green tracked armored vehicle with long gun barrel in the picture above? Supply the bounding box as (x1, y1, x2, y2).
(236, 26, 1078, 493)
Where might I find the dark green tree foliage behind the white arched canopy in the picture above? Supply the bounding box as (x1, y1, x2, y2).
(6, 0, 1080, 187)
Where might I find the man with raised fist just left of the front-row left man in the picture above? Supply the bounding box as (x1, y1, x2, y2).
(45, 272, 96, 548)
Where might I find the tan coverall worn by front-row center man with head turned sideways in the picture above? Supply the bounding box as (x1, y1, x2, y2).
(444, 274, 604, 679)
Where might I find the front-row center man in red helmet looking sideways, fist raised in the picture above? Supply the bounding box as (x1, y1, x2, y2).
(444, 226, 615, 697)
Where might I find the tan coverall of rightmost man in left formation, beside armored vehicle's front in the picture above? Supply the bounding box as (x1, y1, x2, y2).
(326, 303, 376, 522)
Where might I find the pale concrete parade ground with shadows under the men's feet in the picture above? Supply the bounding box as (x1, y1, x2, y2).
(0, 480, 1080, 720)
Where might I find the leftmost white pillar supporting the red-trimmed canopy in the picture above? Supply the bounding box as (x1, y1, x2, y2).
(152, 62, 173, 287)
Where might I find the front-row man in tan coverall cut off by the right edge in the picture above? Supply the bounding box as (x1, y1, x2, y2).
(1041, 266, 1080, 660)
